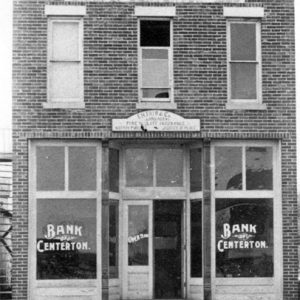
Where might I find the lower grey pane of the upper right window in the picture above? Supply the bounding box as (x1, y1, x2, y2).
(230, 63, 257, 99)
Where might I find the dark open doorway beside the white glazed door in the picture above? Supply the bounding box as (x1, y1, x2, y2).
(154, 200, 182, 299)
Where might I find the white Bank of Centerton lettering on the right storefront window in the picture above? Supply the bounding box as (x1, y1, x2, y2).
(217, 223, 268, 252)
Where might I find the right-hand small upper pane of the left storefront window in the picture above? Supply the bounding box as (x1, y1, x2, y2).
(69, 147, 97, 191)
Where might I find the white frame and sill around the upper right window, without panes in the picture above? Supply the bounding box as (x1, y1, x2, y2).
(226, 19, 267, 110)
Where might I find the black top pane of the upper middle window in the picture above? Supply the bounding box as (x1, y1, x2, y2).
(140, 20, 170, 47)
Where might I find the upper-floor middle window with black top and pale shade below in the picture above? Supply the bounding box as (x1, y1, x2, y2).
(139, 19, 173, 102)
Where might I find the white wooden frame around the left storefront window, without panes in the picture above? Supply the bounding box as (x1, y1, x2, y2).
(28, 140, 102, 300)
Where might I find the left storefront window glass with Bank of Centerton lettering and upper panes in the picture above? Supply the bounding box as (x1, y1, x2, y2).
(35, 143, 97, 280)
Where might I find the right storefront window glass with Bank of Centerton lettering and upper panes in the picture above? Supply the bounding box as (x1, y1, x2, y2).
(214, 142, 275, 277)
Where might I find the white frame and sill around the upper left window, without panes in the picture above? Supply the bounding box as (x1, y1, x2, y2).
(43, 17, 84, 108)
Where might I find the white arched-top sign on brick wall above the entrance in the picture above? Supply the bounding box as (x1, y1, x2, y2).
(112, 110, 200, 132)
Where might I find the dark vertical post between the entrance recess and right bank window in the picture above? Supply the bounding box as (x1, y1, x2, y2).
(203, 139, 212, 300)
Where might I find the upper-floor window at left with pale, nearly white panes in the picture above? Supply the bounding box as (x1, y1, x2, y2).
(48, 18, 83, 103)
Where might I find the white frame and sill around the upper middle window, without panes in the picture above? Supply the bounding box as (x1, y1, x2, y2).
(136, 18, 177, 109)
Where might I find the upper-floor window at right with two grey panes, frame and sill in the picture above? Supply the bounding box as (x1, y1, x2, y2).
(227, 20, 265, 109)
